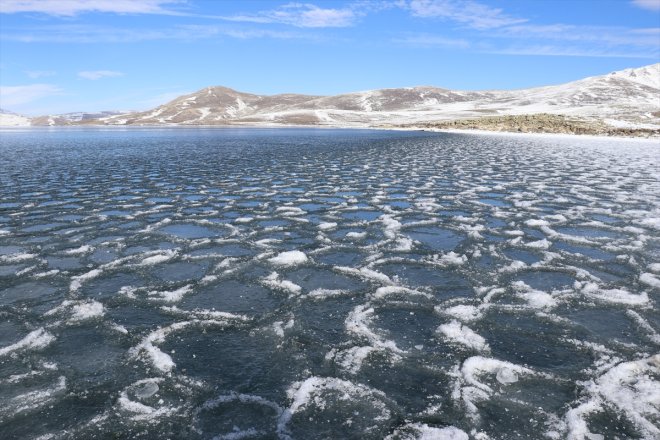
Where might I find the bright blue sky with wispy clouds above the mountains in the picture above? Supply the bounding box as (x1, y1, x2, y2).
(0, 0, 660, 115)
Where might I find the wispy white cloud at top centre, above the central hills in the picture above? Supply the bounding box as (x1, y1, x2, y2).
(220, 3, 361, 28)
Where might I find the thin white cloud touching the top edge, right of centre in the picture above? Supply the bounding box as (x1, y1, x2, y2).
(407, 0, 527, 30)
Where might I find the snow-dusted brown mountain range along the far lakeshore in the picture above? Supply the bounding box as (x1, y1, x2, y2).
(0, 63, 660, 131)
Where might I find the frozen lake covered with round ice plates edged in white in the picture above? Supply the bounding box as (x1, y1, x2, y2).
(0, 129, 660, 440)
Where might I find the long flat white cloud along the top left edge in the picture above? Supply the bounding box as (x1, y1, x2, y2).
(0, 0, 181, 17)
